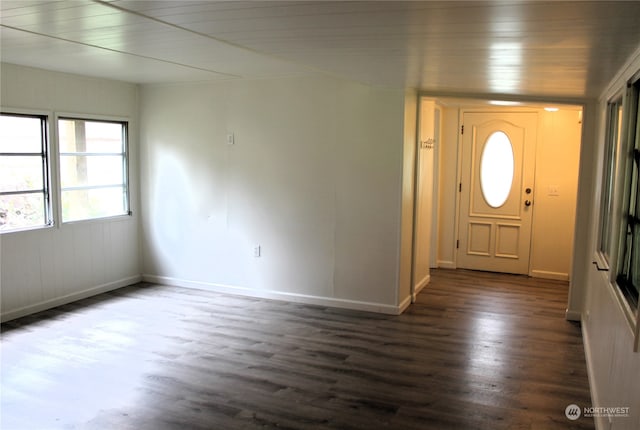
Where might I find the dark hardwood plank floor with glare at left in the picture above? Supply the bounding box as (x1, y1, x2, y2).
(0, 270, 594, 430)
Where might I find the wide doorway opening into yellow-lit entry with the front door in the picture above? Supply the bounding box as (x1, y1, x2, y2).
(412, 96, 583, 293)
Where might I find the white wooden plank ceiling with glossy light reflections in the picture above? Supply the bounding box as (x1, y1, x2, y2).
(0, 0, 640, 98)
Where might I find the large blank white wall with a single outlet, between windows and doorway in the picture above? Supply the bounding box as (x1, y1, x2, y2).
(141, 78, 405, 313)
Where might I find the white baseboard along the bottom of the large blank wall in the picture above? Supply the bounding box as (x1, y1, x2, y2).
(142, 274, 404, 315)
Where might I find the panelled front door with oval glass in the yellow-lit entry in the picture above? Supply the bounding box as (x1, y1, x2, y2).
(457, 112, 537, 274)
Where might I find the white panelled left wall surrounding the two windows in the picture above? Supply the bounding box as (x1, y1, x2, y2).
(0, 64, 140, 321)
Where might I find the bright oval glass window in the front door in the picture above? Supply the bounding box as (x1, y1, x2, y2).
(480, 131, 515, 208)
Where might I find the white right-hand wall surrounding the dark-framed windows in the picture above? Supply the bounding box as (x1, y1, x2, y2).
(584, 47, 640, 430)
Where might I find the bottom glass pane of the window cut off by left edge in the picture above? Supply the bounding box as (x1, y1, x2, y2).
(0, 193, 46, 231)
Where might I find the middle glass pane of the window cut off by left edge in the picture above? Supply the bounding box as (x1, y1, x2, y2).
(0, 155, 44, 192)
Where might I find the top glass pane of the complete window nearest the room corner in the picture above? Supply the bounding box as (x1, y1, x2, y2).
(58, 119, 124, 153)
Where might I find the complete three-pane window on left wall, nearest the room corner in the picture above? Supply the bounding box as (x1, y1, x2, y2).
(58, 117, 129, 222)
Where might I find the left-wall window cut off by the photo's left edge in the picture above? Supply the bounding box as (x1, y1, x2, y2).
(0, 112, 53, 232)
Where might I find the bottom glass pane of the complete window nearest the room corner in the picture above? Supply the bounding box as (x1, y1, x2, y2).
(62, 187, 127, 221)
